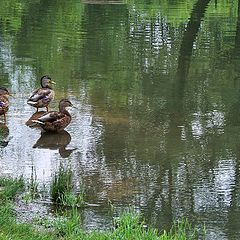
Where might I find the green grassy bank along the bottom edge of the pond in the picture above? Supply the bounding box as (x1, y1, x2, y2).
(0, 179, 201, 240)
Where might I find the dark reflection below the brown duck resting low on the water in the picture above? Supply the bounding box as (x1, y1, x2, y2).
(33, 130, 76, 158)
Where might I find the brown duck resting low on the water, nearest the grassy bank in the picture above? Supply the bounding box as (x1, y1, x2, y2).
(32, 99, 73, 132)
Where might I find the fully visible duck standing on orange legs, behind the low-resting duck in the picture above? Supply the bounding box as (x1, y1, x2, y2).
(27, 75, 55, 112)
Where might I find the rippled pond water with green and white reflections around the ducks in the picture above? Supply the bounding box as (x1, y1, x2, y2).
(0, 0, 240, 240)
